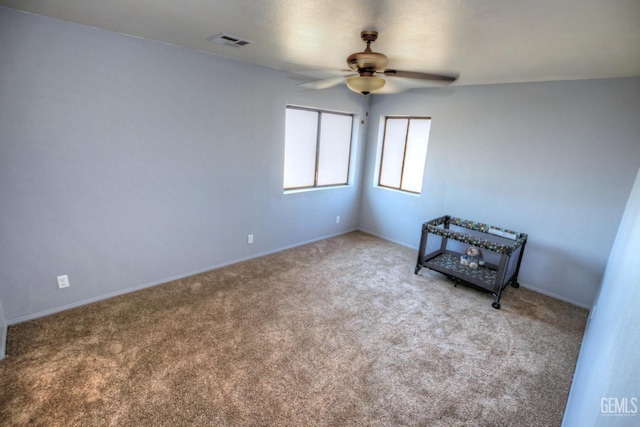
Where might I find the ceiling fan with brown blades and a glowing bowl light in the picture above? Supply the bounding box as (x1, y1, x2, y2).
(301, 30, 458, 95)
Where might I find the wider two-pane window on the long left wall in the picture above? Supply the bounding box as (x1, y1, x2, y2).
(284, 106, 353, 190)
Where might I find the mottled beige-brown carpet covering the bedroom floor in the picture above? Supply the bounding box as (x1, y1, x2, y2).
(0, 232, 587, 426)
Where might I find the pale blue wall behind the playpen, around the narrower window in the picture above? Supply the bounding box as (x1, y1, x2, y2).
(360, 78, 640, 307)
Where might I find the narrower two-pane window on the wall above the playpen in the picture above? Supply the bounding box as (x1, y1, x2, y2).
(378, 117, 431, 194)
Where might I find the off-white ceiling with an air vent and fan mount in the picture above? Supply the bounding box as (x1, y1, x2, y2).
(0, 0, 640, 91)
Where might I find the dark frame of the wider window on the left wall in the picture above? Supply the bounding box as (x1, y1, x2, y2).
(282, 104, 356, 192)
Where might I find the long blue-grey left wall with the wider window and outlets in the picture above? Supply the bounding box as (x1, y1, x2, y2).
(0, 7, 364, 324)
